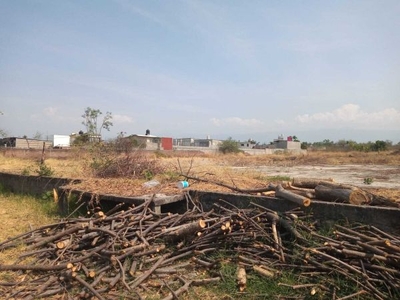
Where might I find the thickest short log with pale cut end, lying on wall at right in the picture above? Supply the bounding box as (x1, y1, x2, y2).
(315, 185, 370, 205)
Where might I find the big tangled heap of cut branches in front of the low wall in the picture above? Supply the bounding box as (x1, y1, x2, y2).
(0, 194, 400, 299)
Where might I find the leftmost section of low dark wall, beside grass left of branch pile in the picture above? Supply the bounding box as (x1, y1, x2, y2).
(0, 172, 76, 195)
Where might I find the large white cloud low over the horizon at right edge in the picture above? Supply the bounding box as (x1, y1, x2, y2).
(295, 103, 400, 129)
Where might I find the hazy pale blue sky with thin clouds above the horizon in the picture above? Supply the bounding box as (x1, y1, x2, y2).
(0, 0, 400, 143)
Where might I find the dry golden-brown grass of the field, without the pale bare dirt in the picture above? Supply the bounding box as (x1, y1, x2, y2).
(0, 149, 400, 199)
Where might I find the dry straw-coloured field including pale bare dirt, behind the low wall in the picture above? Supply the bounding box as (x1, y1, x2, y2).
(0, 150, 400, 201)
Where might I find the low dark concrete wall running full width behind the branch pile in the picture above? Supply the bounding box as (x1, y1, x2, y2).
(0, 172, 400, 233)
